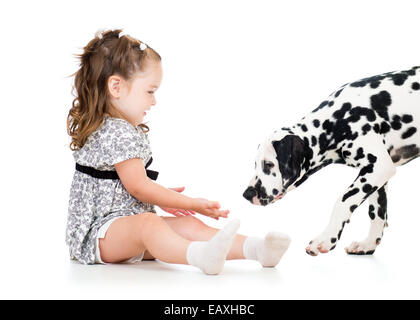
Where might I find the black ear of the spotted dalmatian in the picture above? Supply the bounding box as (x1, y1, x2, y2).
(272, 135, 305, 188)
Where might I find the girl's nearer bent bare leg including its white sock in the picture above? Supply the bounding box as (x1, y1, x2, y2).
(99, 212, 239, 274)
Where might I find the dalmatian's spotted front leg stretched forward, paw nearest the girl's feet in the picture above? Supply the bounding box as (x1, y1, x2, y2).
(306, 135, 395, 256)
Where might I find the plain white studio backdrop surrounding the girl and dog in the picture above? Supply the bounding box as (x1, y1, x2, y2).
(0, 0, 420, 299)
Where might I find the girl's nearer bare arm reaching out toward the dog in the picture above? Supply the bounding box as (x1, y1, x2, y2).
(114, 158, 229, 217)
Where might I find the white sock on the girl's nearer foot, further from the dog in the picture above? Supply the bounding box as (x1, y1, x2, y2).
(187, 219, 240, 274)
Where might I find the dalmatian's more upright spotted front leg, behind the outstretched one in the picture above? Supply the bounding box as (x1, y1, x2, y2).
(346, 184, 388, 255)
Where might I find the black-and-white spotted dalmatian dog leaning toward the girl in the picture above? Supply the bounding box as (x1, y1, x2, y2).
(243, 67, 420, 256)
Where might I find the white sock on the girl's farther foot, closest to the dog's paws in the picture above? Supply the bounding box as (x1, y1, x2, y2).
(243, 232, 290, 267)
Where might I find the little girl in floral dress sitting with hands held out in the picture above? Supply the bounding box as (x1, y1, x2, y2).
(66, 30, 290, 274)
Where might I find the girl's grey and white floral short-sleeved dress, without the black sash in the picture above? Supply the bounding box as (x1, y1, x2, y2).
(66, 116, 156, 264)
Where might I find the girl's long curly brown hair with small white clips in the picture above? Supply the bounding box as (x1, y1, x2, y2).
(67, 29, 161, 151)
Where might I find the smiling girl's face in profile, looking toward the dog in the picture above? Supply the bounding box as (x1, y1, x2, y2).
(111, 61, 162, 127)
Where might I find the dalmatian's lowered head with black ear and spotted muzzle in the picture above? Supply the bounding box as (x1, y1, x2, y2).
(243, 130, 306, 206)
